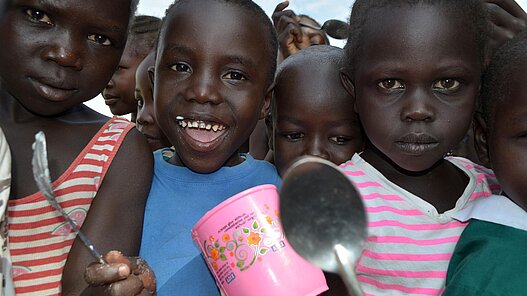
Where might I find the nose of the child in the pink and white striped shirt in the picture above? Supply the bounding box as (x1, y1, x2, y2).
(401, 89, 437, 121)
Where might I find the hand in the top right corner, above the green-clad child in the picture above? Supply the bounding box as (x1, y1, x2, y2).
(483, 0, 527, 54)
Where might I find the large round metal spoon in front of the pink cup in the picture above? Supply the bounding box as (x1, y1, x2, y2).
(280, 156, 367, 295)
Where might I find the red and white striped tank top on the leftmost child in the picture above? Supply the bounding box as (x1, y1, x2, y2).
(8, 117, 134, 296)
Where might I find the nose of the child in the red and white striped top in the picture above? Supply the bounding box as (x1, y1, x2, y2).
(42, 37, 82, 70)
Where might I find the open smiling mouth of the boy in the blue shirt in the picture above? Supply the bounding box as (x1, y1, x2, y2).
(176, 116, 227, 151)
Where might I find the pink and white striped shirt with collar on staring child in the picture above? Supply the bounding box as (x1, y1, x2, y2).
(340, 154, 499, 295)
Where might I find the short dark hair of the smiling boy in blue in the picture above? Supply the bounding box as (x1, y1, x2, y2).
(160, 0, 278, 86)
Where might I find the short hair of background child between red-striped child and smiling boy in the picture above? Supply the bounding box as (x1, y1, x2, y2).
(128, 15, 161, 58)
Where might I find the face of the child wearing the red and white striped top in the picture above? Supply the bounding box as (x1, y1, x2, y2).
(0, 0, 130, 115)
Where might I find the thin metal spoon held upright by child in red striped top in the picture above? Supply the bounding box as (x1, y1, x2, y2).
(31, 131, 106, 264)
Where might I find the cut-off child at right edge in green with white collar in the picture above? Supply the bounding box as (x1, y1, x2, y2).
(443, 31, 527, 295)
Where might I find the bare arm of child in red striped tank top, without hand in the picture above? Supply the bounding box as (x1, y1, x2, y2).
(62, 129, 153, 295)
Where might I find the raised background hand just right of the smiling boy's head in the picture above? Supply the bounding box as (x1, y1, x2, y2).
(272, 1, 310, 59)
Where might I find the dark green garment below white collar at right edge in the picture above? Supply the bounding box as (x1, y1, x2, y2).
(443, 220, 527, 295)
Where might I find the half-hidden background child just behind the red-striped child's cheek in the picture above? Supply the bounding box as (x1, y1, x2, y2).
(102, 15, 161, 122)
